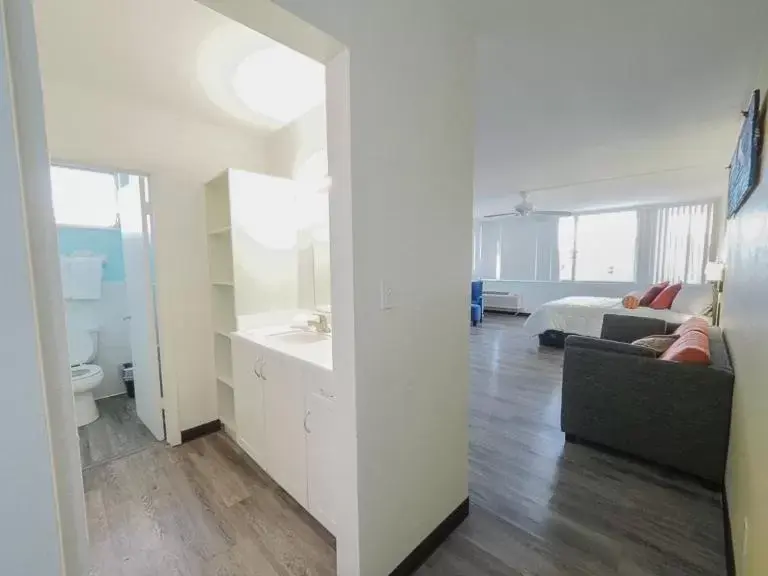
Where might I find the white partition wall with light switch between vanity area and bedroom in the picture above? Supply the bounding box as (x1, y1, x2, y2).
(270, 0, 474, 576)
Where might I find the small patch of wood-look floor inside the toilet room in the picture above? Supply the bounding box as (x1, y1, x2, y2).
(78, 394, 157, 468)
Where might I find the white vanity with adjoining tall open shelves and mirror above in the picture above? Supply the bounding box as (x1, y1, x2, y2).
(205, 170, 338, 533)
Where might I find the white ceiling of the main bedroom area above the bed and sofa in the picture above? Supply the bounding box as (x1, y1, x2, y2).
(475, 0, 768, 214)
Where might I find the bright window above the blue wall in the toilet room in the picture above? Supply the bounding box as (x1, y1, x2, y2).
(51, 166, 117, 228)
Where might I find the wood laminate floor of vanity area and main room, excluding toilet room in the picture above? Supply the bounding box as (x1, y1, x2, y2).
(84, 316, 725, 576)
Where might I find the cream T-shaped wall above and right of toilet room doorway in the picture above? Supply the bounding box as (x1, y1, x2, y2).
(43, 78, 265, 430)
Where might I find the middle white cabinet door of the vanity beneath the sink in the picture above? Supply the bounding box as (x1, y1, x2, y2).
(261, 350, 307, 508)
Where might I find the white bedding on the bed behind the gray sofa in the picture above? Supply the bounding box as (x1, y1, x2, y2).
(525, 296, 692, 338)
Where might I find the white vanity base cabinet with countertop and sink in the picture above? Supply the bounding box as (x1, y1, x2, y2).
(232, 326, 338, 533)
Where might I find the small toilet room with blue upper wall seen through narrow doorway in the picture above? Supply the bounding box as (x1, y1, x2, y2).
(51, 165, 164, 469)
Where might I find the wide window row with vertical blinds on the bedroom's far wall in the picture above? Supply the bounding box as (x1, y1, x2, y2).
(474, 202, 715, 283)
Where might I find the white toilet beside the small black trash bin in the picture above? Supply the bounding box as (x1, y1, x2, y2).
(69, 330, 104, 426)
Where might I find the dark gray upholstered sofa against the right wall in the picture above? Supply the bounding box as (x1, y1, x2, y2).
(561, 314, 734, 486)
